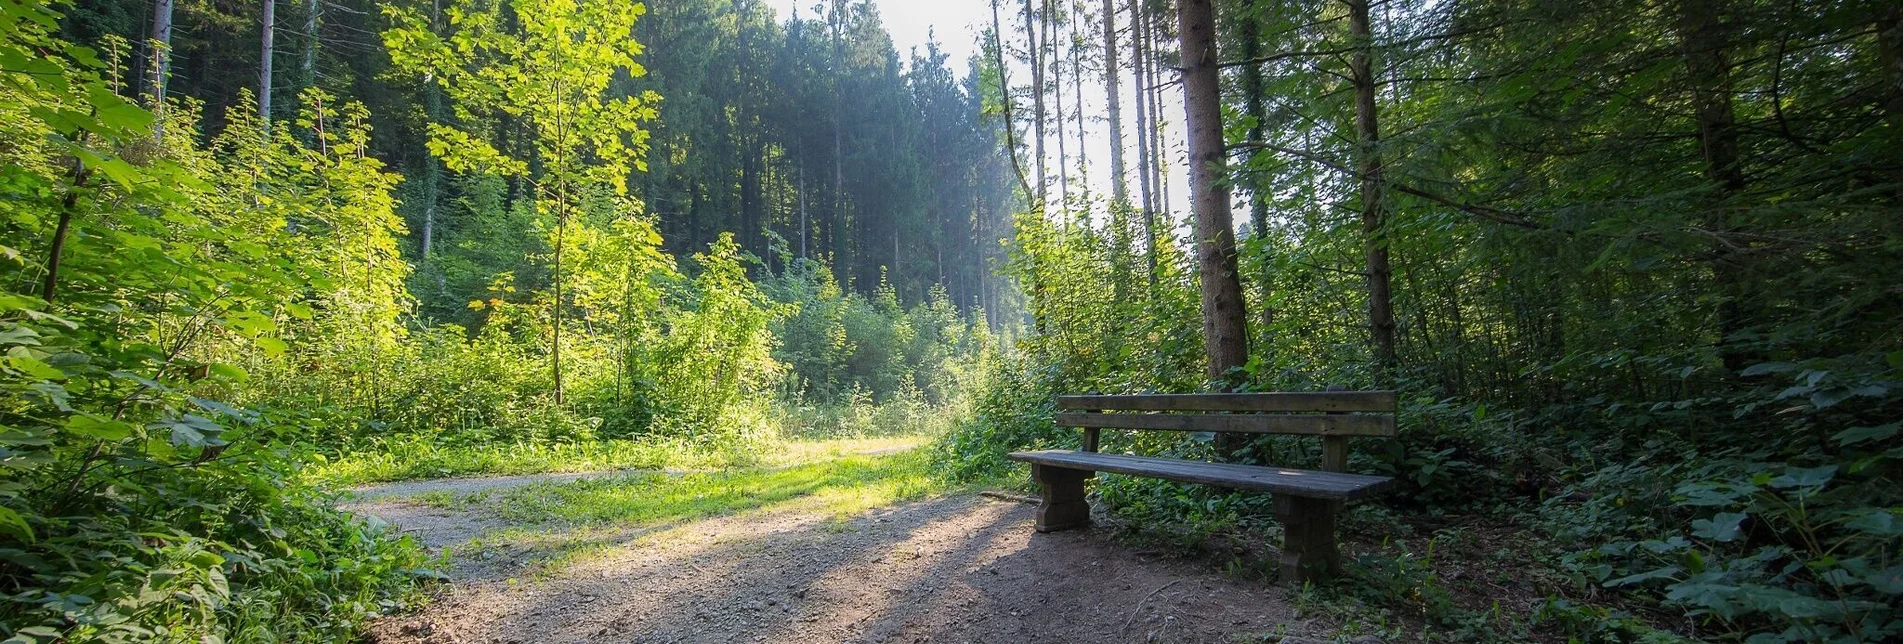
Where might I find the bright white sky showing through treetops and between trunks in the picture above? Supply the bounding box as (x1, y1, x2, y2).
(767, 0, 1187, 231)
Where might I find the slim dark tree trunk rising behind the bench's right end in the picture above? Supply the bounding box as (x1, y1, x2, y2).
(1347, 0, 1397, 370)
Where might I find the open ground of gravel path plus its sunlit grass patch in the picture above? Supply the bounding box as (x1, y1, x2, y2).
(346, 453, 1361, 644)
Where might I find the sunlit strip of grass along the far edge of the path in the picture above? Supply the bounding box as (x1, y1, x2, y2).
(303, 436, 927, 486)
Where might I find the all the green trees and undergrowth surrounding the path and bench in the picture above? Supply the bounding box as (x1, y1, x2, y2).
(0, 0, 1903, 642)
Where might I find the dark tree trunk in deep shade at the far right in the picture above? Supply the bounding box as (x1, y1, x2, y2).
(1678, 0, 1751, 373)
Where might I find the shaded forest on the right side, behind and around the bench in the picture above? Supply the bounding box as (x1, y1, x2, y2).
(948, 0, 1903, 642)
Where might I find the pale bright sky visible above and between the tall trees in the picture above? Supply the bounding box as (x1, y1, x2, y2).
(767, 0, 1187, 225)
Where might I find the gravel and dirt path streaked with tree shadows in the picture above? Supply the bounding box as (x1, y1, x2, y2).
(342, 472, 1372, 644)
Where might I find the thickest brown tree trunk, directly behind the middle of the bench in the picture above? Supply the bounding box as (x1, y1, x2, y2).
(1176, 0, 1248, 385)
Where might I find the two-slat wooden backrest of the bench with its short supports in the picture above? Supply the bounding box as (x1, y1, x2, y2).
(1056, 391, 1399, 473)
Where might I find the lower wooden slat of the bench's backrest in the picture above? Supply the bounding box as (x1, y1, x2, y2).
(1056, 412, 1395, 436)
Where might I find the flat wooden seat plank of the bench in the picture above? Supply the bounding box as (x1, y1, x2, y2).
(1010, 450, 1393, 501)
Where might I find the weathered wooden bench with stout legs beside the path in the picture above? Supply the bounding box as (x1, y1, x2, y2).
(1010, 391, 1397, 583)
